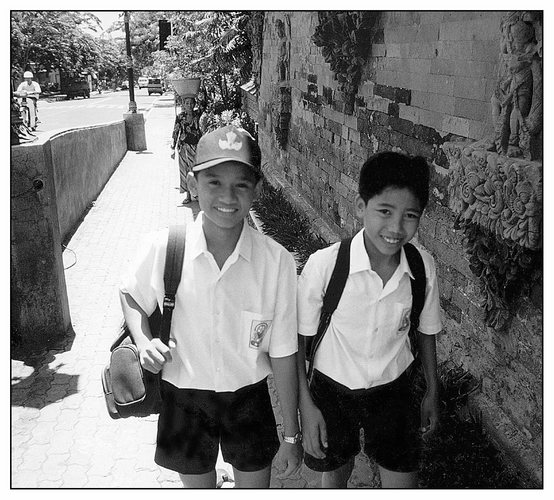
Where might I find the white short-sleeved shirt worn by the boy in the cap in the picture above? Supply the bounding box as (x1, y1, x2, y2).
(121, 213, 298, 392)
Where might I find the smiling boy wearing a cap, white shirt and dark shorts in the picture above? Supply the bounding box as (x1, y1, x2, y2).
(121, 126, 301, 488)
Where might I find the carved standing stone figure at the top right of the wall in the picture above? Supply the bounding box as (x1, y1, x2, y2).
(488, 11, 543, 160)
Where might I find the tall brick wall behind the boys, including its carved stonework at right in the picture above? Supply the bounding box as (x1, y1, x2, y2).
(259, 11, 542, 477)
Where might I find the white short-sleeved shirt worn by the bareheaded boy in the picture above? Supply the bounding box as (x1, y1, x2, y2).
(298, 230, 442, 389)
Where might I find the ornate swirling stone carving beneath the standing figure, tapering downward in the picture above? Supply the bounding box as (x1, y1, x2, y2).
(442, 142, 543, 330)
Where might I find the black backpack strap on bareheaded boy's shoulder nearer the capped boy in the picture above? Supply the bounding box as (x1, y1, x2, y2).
(306, 238, 352, 381)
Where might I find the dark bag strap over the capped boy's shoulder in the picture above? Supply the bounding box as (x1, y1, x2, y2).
(159, 224, 186, 345)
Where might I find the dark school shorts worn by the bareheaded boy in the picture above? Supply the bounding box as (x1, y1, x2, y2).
(304, 370, 421, 472)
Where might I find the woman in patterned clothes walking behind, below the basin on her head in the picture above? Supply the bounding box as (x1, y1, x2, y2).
(171, 95, 202, 205)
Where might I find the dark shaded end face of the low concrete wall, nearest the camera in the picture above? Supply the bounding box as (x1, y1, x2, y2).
(10, 142, 71, 345)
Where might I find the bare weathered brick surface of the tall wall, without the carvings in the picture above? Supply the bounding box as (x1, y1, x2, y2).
(257, 11, 542, 475)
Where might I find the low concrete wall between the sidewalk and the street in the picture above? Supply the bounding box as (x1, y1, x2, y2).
(10, 121, 127, 346)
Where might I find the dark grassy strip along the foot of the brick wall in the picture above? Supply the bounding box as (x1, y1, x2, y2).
(253, 180, 525, 489)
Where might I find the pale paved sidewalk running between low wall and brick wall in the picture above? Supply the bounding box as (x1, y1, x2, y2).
(11, 97, 374, 488)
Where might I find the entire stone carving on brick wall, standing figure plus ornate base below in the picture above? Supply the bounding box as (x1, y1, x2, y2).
(442, 11, 543, 330)
